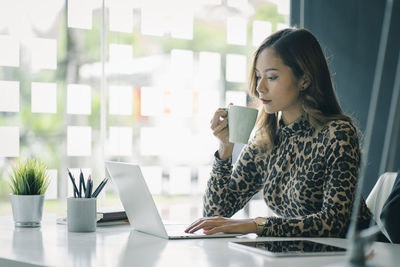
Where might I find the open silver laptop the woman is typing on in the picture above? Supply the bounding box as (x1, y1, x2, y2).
(105, 161, 238, 239)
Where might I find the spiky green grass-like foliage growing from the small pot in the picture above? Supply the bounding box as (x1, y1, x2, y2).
(10, 159, 49, 195)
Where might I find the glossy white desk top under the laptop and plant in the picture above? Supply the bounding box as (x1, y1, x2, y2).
(0, 216, 400, 267)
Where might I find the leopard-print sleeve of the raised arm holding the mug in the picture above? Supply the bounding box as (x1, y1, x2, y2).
(203, 140, 264, 217)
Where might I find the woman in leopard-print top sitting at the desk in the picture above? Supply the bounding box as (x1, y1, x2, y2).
(186, 29, 371, 237)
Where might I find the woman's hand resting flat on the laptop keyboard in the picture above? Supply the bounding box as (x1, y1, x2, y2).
(185, 217, 256, 235)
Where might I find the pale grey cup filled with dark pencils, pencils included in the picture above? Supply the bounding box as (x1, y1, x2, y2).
(67, 170, 108, 232)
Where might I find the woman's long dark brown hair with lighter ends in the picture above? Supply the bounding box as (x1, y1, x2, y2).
(249, 28, 351, 150)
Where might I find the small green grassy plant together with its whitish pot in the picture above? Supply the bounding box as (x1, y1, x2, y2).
(10, 159, 49, 227)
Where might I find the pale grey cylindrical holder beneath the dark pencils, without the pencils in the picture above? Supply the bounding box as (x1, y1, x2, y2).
(67, 197, 96, 232)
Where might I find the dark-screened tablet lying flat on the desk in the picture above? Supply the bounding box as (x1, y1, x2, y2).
(229, 240, 346, 257)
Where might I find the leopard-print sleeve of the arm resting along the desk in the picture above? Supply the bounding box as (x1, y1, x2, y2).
(262, 121, 360, 237)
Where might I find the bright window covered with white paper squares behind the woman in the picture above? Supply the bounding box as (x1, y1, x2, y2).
(0, 0, 290, 222)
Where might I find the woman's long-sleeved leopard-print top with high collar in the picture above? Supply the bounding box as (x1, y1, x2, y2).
(203, 116, 371, 237)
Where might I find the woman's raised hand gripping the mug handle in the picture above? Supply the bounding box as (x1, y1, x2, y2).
(211, 108, 233, 160)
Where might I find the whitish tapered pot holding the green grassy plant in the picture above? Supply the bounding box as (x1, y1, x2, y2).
(10, 194, 44, 227)
